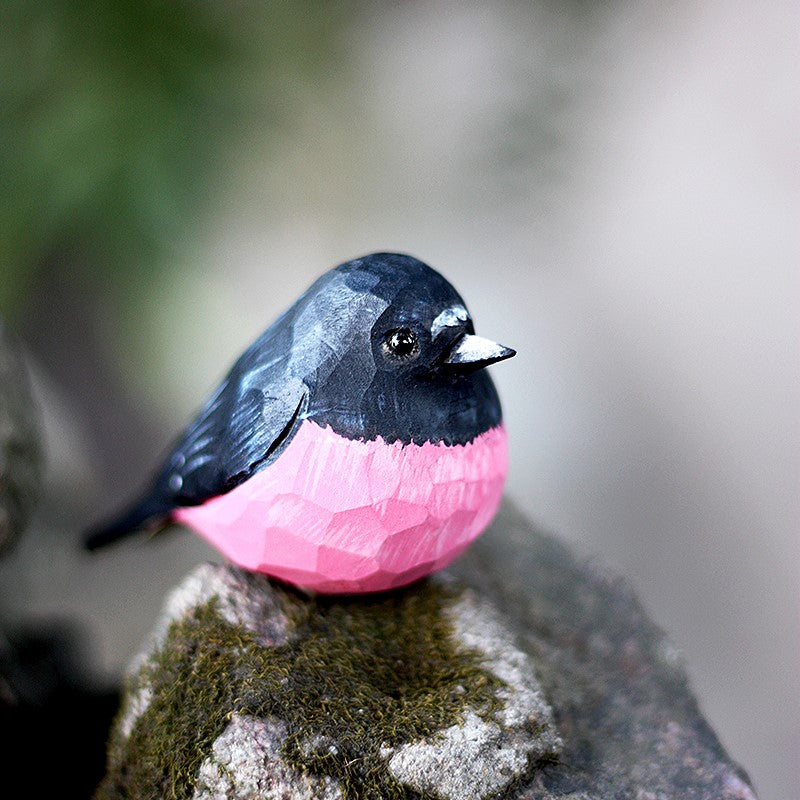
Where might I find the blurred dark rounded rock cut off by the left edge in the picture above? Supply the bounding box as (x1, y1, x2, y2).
(0, 319, 42, 553)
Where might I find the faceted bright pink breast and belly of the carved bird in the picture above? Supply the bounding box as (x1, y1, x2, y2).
(173, 420, 508, 593)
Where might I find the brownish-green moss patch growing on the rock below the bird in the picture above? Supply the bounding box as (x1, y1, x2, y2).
(97, 583, 500, 800)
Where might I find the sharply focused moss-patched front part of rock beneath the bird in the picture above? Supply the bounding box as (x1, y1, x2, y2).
(97, 565, 560, 800)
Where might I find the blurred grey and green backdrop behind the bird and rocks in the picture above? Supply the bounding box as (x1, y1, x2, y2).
(0, 0, 800, 800)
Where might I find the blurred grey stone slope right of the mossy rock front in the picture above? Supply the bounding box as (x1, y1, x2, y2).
(451, 504, 755, 800)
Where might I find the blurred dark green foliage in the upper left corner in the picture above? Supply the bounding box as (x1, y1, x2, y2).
(0, 0, 345, 315)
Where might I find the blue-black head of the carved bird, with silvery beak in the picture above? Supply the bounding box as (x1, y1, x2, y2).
(292, 253, 514, 444)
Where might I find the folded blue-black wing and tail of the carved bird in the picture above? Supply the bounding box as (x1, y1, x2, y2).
(86, 332, 308, 550)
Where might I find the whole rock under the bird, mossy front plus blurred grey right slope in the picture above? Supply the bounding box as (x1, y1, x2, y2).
(96, 506, 755, 800)
